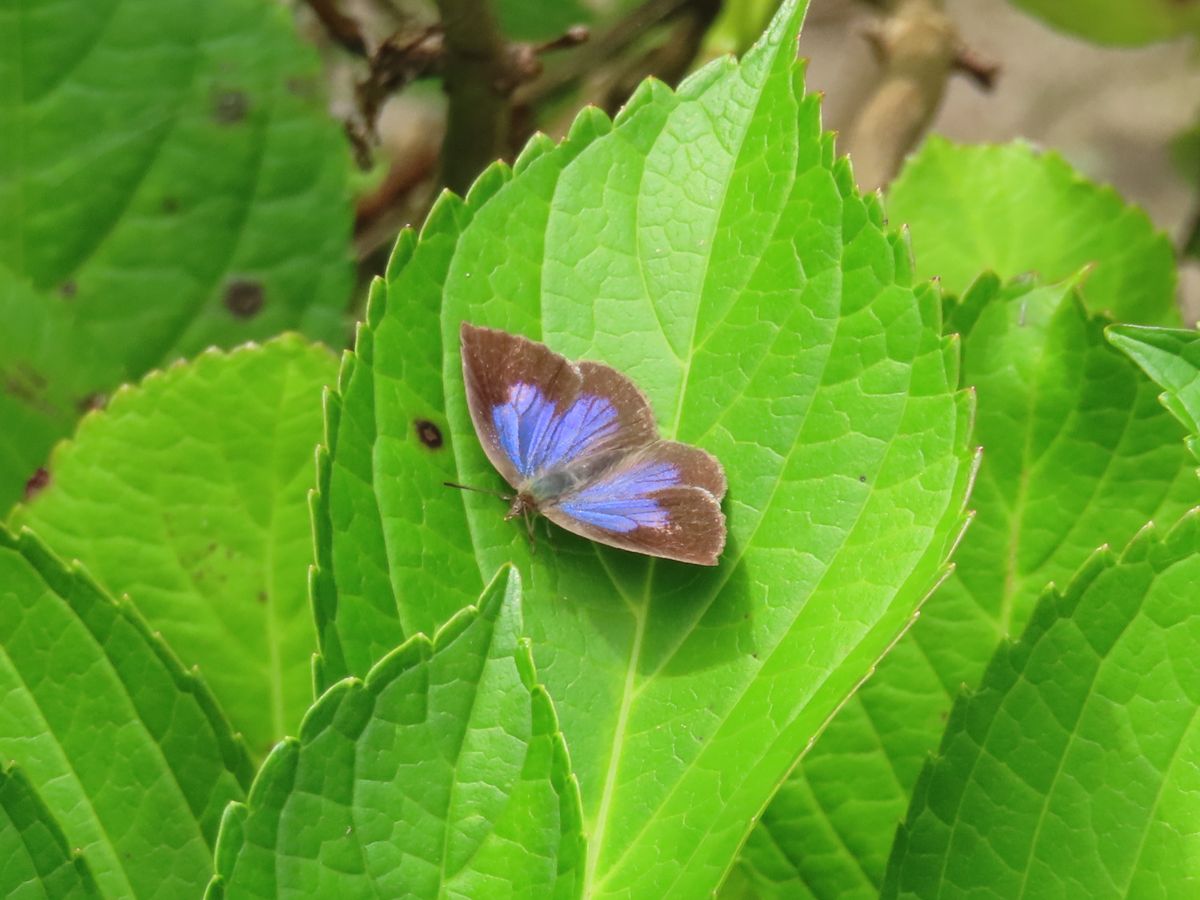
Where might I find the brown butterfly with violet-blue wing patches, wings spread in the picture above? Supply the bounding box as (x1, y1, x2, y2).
(455, 323, 726, 565)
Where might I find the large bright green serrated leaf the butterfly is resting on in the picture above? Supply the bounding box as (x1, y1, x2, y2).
(314, 4, 972, 896)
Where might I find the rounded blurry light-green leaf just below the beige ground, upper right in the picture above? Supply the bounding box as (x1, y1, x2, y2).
(888, 136, 1180, 325)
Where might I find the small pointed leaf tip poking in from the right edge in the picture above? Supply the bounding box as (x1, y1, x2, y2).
(1108, 325, 1200, 457)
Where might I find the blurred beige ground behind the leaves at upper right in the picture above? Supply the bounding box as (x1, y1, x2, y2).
(800, 0, 1200, 324)
